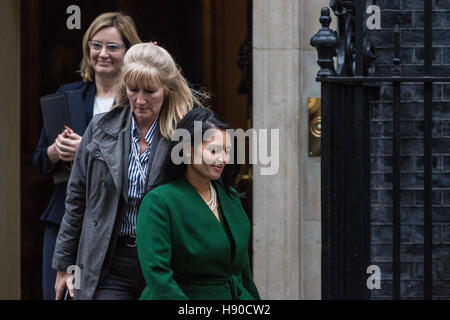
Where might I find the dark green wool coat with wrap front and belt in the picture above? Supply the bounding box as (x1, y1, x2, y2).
(136, 176, 259, 300)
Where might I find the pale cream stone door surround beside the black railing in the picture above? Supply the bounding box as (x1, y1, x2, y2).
(253, 0, 330, 299)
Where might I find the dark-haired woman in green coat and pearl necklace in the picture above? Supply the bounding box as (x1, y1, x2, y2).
(136, 108, 259, 300)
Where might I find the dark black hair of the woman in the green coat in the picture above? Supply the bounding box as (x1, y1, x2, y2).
(159, 107, 240, 195)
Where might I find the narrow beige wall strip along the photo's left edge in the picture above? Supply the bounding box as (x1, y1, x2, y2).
(0, 0, 20, 299)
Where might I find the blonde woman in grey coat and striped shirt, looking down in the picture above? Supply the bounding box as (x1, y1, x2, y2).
(53, 43, 206, 300)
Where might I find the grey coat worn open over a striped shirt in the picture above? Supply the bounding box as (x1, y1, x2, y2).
(52, 106, 169, 300)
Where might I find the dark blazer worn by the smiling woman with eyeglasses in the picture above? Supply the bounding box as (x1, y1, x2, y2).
(33, 81, 95, 225)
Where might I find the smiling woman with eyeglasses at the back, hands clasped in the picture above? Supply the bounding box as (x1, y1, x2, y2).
(33, 12, 141, 300)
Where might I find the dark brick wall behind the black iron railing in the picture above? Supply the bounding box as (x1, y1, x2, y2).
(369, 0, 450, 299)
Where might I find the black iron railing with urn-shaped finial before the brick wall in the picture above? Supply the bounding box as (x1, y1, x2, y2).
(311, 0, 450, 299)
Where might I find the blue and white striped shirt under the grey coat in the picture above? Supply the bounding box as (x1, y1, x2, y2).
(119, 114, 158, 236)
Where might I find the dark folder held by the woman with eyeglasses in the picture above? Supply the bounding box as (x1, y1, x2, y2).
(41, 90, 86, 145)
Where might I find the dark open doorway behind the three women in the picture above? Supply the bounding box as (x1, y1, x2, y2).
(21, 0, 251, 299)
